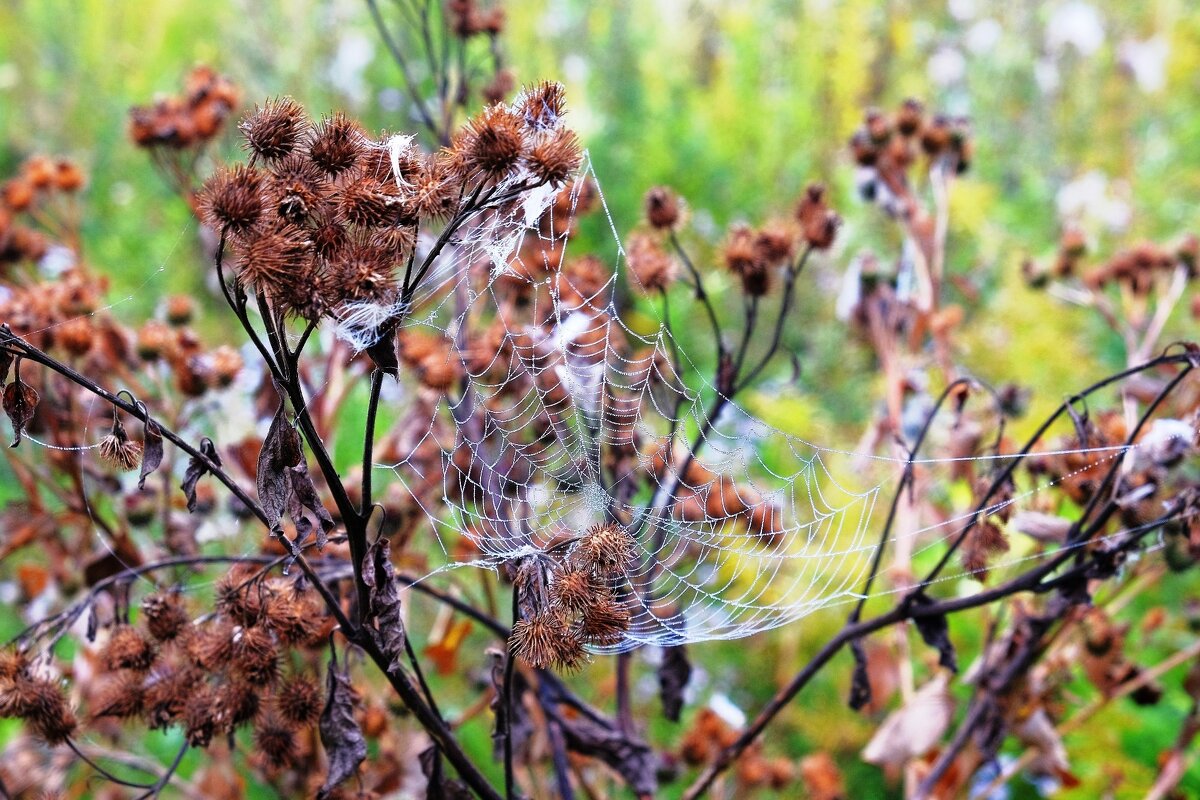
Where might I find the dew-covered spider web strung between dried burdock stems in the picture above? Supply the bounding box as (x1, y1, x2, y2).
(357, 140, 1171, 651)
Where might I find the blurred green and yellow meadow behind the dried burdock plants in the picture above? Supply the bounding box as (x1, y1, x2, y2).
(0, 0, 1200, 798)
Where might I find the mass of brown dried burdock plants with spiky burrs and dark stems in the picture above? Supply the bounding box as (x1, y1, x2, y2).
(7, 10, 1200, 800)
